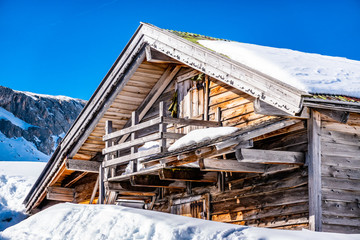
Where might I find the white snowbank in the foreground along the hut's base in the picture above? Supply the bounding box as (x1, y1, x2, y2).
(0, 203, 360, 240)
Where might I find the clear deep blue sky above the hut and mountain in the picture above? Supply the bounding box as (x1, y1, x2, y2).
(0, 0, 360, 100)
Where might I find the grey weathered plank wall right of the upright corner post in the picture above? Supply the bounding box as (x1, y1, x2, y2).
(321, 114, 360, 233)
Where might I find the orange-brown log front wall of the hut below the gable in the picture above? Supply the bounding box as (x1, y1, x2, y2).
(154, 79, 309, 229)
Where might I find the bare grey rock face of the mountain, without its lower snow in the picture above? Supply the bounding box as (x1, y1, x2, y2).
(0, 86, 86, 158)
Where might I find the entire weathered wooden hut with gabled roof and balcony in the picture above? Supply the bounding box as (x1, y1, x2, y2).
(24, 23, 360, 233)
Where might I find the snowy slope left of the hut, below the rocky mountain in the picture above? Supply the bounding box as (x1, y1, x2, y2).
(0, 161, 45, 231)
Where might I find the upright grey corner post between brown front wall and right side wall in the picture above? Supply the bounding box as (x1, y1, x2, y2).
(308, 110, 322, 231)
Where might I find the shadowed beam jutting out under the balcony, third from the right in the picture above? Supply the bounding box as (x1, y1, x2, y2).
(159, 168, 217, 182)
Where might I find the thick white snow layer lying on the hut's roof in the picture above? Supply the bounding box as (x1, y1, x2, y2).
(198, 40, 360, 97)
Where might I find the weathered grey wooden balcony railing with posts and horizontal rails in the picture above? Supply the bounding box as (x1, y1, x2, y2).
(103, 102, 220, 177)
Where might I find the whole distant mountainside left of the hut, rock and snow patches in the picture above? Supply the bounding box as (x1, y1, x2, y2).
(0, 86, 86, 161)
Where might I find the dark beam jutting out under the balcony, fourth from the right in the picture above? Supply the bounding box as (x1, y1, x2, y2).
(130, 175, 185, 189)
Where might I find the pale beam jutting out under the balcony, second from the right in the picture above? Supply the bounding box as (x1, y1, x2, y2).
(199, 158, 265, 173)
